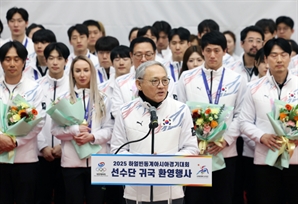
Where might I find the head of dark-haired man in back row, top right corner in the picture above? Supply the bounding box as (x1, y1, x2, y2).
(275, 16, 294, 40)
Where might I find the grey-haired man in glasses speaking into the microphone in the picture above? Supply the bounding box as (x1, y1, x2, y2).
(111, 61, 198, 204)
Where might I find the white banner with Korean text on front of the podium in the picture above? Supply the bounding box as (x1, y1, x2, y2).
(91, 154, 212, 186)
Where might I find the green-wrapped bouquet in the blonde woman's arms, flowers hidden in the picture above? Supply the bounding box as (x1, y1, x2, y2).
(47, 98, 101, 159)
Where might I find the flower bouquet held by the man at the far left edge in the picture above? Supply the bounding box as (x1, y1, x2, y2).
(0, 95, 42, 164)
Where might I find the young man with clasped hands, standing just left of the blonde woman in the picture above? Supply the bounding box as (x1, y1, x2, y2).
(34, 41, 69, 204)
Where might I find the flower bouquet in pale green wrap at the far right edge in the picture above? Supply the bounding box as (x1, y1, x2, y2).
(265, 100, 298, 169)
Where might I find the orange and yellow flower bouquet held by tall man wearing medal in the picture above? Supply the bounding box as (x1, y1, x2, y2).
(186, 101, 233, 171)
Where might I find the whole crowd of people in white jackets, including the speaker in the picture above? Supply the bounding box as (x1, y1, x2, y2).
(0, 7, 298, 204)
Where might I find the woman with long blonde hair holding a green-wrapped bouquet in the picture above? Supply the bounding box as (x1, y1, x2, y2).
(52, 56, 113, 204)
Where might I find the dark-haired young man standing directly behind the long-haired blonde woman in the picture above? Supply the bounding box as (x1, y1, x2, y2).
(65, 24, 107, 83)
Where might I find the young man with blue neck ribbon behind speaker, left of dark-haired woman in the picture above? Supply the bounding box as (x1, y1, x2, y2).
(164, 27, 190, 82)
